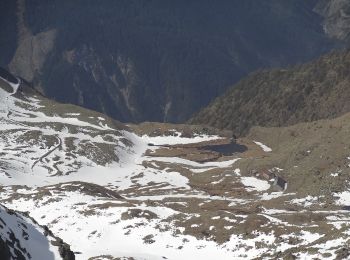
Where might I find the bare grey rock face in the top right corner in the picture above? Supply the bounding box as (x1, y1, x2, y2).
(315, 0, 350, 41)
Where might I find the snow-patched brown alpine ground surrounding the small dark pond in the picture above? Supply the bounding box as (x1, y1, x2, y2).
(0, 69, 350, 260)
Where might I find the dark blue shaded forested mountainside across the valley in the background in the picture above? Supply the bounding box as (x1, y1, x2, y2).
(0, 0, 335, 122)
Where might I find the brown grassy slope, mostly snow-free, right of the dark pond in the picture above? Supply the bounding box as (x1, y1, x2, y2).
(235, 110, 350, 196)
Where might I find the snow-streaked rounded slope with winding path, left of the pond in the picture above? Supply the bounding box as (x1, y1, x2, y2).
(0, 67, 131, 184)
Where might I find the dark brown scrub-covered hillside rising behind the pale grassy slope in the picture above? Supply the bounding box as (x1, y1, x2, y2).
(190, 48, 350, 135)
